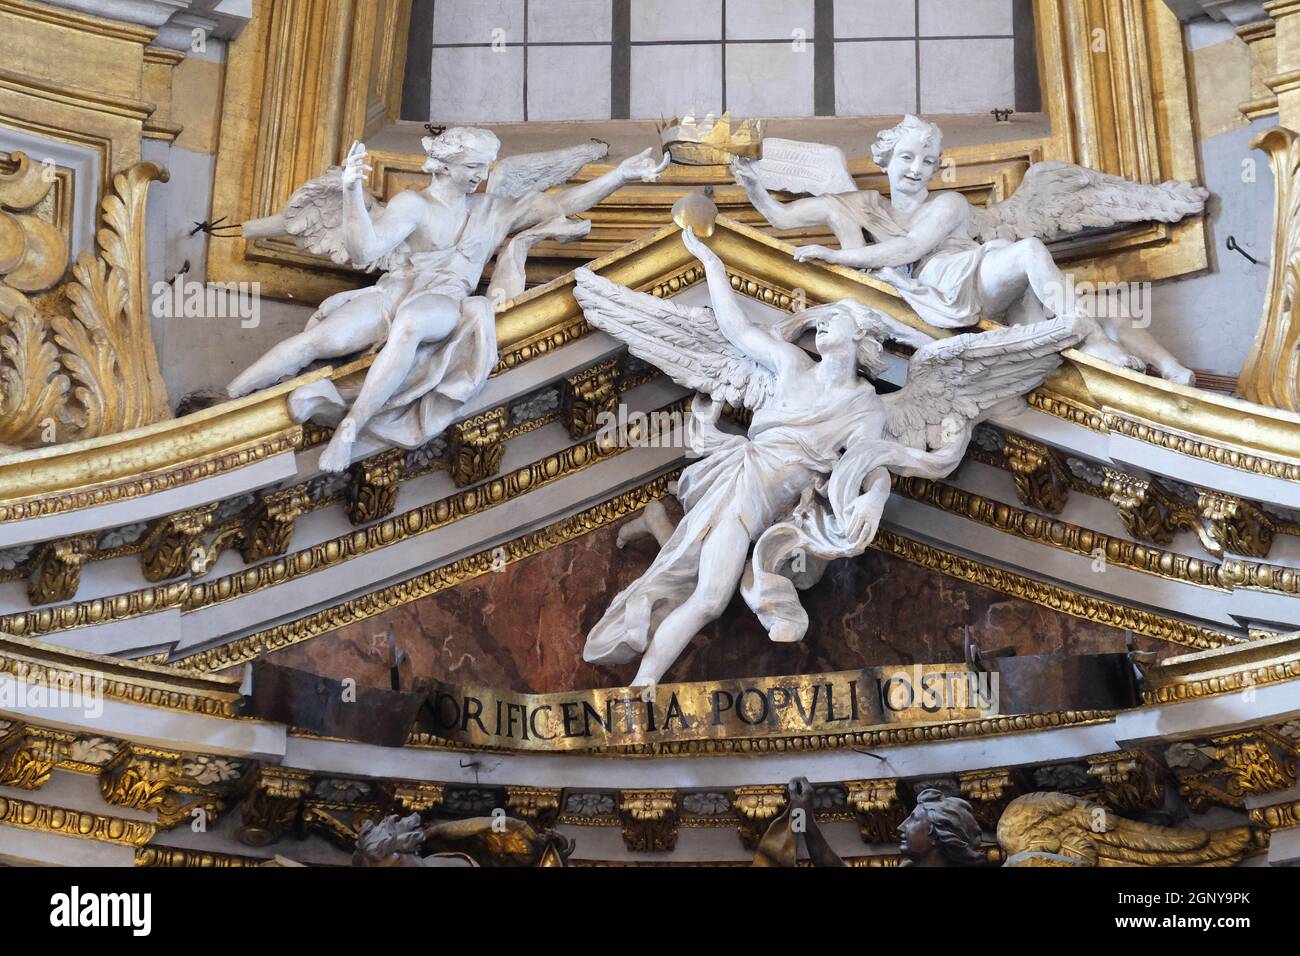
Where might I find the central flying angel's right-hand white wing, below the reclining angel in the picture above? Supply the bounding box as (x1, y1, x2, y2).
(881, 319, 1082, 451)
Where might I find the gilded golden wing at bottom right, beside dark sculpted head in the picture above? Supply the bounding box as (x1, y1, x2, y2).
(997, 793, 1252, 866)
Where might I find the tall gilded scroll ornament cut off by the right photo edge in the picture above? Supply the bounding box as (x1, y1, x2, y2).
(1238, 126, 1300, 411)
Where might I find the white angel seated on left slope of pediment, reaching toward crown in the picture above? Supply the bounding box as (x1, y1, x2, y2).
(228, 126, 670, 471)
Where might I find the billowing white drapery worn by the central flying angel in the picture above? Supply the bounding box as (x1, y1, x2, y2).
(582, 390, 969, 663)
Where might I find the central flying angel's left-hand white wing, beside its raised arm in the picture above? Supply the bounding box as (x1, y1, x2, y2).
(573, 269, 776, 408)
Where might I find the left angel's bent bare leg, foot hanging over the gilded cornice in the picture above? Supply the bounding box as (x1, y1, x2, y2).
(320, 294, 460, 471)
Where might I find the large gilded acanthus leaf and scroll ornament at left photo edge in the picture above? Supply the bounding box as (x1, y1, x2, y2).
(0, 157, 172, 449)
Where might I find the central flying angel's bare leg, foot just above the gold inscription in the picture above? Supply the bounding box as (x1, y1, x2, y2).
(632, 515, 750, 695)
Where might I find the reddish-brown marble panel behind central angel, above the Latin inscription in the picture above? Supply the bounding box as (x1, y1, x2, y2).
(248, 509, 1186, 693)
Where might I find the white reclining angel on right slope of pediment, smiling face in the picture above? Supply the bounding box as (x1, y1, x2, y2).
(732, 116, 1209, 385)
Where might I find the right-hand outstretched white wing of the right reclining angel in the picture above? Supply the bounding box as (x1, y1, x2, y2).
(971, 161, 1210, 242)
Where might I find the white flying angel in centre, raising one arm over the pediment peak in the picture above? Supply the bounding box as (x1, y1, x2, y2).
(575, 229, 1079, 693)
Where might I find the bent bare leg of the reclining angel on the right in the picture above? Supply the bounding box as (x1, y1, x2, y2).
(979, 239, 1145, 372)
